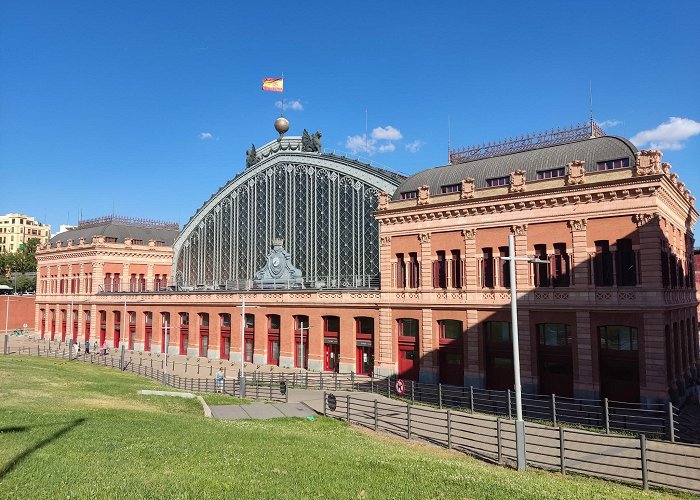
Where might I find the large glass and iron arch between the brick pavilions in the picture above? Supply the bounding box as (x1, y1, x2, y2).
(173, 137, 403, 289)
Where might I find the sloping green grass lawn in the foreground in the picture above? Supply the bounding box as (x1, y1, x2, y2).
(0, 356, 684, 500)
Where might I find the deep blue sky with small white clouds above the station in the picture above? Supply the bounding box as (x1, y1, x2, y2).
(0, 0, 700, 232)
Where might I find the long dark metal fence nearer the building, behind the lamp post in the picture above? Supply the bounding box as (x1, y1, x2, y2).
(5, 341, 680, 442)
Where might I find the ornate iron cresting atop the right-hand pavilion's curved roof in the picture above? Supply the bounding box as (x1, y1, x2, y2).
(449, 118, 605, 163)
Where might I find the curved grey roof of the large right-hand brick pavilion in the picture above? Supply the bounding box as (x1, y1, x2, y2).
(393, 136, 637, 200)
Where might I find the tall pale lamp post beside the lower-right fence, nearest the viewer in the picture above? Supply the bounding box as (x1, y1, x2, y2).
(501, 234, 549, 471)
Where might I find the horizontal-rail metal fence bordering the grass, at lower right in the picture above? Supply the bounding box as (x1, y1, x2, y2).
(324, 392, 700, 494)
